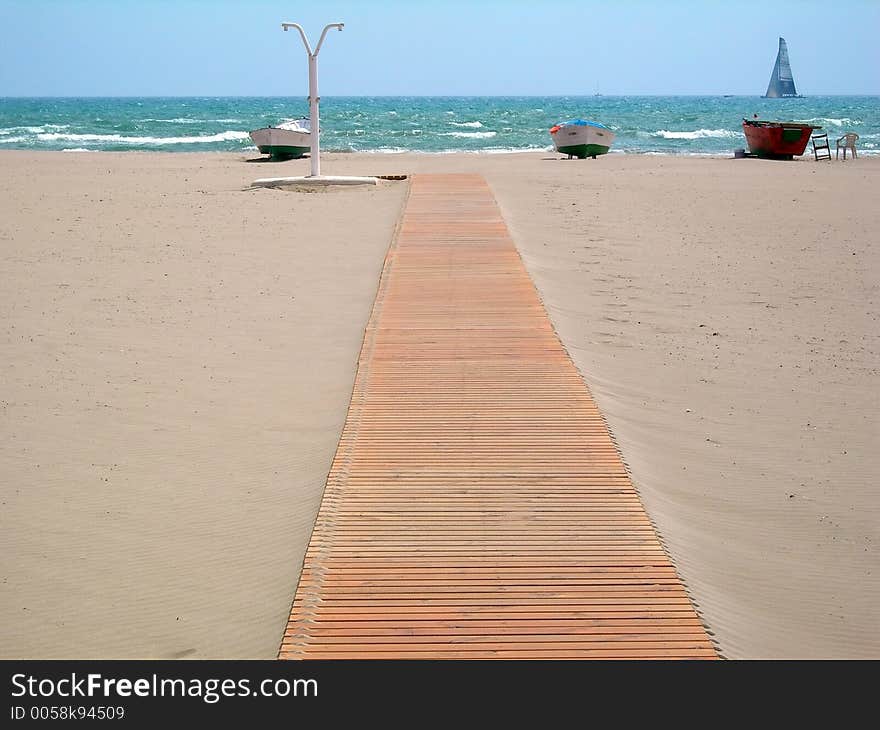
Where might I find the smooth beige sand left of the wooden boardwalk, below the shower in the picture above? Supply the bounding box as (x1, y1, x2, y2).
(0, 152, 405, 658)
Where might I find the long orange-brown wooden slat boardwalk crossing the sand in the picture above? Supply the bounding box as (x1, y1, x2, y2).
(279, 175, 716, 659)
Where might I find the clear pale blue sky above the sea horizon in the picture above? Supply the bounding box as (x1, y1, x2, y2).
(0, 0, 880, 96)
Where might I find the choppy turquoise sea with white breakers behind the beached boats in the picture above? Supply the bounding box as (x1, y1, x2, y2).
(0, 94, 880, 156)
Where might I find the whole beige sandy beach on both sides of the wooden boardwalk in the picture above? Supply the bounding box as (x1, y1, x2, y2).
(0, 152, 880, 658)
